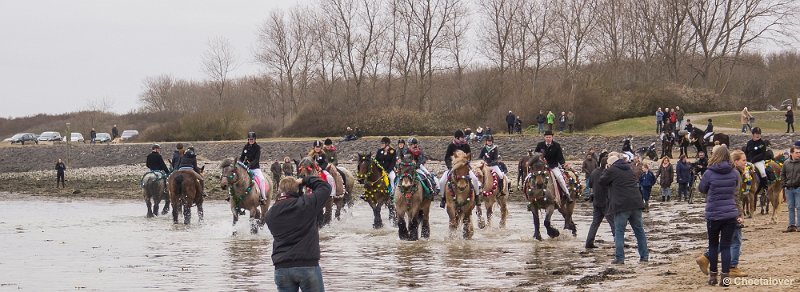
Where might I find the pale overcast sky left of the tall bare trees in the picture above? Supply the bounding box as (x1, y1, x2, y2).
(0, 0, 302, 117)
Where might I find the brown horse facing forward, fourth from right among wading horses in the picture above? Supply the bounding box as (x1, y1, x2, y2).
(394, 155, 433, 241)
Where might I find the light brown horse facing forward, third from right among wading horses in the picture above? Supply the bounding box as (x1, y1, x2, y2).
(444, 150, 479, 239)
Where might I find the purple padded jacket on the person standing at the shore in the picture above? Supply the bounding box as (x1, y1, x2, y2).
(699, 161, 739, 221)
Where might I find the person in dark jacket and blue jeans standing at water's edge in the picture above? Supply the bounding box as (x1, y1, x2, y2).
(599, 154, 649, 265)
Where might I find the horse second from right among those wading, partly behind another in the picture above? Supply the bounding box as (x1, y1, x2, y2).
(474, 161, 508, 229)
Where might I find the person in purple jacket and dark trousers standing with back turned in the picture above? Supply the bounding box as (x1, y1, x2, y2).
(698, 145, 744, 286)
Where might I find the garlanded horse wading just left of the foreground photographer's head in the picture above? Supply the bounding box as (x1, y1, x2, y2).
(219, 159, 272, 234)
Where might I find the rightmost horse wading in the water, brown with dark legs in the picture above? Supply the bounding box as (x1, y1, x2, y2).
(523, 154, 582, 240)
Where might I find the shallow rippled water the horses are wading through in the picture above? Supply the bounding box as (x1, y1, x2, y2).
(0, 194, 705, 291)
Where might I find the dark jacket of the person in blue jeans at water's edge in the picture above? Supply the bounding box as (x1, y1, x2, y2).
(599, 159, 644, 215)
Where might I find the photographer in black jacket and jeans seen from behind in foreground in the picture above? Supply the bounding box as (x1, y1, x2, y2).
(266, 176, 331, 291)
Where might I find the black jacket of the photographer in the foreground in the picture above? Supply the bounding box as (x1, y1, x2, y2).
(267, 176, 331, 269)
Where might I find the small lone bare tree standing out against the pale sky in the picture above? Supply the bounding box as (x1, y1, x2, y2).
(203, 37, 237, 106)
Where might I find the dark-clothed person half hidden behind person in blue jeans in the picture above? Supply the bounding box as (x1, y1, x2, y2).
(585, 156, 614, 248)
